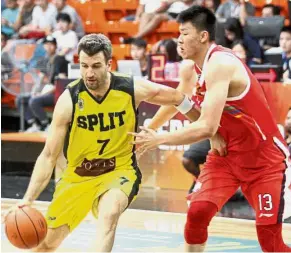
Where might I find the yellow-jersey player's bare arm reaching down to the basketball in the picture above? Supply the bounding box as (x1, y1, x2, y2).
(24, 90, 73, 203)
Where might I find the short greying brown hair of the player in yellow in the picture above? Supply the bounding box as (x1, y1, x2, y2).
(78, 33, 112, 62)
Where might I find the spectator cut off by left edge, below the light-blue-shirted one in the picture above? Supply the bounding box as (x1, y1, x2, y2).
(1, 33, 14, 80)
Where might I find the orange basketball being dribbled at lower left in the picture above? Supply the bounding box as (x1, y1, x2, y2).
(5, 206, 47, 249)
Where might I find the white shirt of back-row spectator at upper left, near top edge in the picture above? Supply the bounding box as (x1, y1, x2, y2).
(31, 3, 57, 29)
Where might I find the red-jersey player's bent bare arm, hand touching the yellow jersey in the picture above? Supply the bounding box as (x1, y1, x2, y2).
(132, 54, 236, 149)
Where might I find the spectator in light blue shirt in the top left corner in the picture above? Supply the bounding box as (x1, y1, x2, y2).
(1, 0, 18, 37)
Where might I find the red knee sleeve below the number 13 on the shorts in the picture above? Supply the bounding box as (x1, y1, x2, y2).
(256, 224, 291, 252)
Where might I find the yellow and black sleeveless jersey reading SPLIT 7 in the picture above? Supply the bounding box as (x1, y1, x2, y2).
(63, 73, 138, 182)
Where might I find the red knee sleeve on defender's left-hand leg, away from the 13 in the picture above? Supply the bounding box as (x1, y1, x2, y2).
(184, 201, 217, 244)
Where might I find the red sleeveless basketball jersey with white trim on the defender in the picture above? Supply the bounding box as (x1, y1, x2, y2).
(193, 44, 288, 168)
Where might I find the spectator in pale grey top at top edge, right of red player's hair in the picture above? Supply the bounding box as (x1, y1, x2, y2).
(216, 0, 256, 26)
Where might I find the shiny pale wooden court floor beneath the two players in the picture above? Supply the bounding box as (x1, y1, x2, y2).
(1, 199, 291, 252)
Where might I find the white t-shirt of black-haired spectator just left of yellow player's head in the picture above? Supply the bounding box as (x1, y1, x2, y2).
(52, 30, 78, 62)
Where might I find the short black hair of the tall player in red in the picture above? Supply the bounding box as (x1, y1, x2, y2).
(177, 5, 216, 41)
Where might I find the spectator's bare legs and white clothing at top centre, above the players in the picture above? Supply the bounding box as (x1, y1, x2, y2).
(120, 0, 193, 44)
